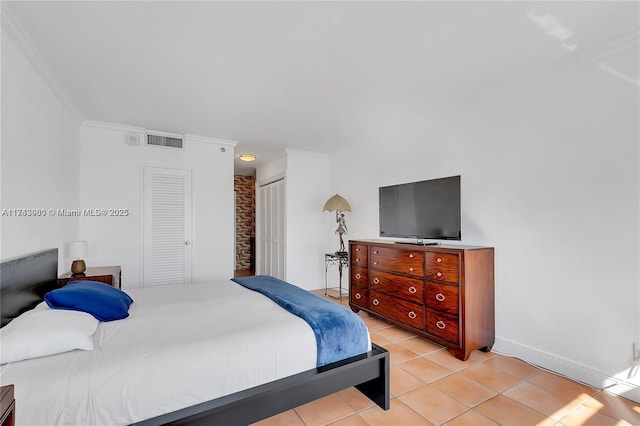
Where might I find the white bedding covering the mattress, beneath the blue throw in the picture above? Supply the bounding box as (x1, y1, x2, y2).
(0, 281, 350, 425)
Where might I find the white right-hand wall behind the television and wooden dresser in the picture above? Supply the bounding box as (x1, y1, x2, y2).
(331, 40, 640, 399)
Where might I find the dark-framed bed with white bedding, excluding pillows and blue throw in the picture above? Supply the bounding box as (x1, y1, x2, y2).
(0, 249, 389, 425)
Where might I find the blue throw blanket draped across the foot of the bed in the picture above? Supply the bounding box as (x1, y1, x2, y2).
(233, 275, 368, 367)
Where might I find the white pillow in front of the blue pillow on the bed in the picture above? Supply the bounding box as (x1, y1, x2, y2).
(0, 305, 100, 364)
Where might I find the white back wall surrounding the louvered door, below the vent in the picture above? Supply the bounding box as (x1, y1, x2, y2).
(78, 123, 235, 288)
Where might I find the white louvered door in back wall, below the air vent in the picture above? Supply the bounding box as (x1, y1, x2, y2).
(142, 167, 192, 287)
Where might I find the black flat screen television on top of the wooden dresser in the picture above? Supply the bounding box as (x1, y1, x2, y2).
(379, 176, 462, 243)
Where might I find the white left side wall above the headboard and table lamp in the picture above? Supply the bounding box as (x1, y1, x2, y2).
(0, 27, 80, 272)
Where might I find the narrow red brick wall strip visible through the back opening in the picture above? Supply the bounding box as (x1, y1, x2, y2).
(233, 175, 256, 269)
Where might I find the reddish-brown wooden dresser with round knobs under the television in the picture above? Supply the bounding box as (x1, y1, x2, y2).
(349, 240, 495, 360)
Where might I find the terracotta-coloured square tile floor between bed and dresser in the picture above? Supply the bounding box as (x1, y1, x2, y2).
(252, 291, 640, 426)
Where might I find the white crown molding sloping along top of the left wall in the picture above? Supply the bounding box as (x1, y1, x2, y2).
(0, 1, 84, 124)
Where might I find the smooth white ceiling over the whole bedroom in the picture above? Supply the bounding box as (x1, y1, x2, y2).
(6, 1, 638, 172)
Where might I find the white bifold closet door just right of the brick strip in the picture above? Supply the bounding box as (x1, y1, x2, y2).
(256, 179, 285, 280)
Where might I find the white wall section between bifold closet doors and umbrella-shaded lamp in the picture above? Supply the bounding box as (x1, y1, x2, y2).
(256, 149, 332, 290)
